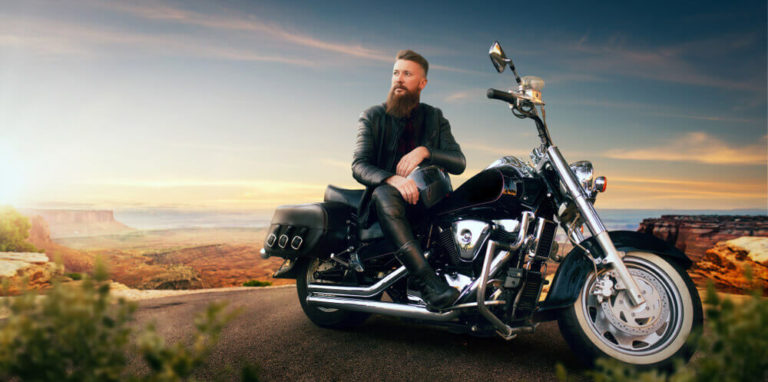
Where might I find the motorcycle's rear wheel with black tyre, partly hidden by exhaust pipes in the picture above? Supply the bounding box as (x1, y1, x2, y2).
(296, 258, 370, 329)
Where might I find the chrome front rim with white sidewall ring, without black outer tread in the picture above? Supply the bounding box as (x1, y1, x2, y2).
(580, 256, 683, 356)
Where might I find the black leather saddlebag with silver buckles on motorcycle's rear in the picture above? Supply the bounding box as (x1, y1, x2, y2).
(264, 202, 355, 259)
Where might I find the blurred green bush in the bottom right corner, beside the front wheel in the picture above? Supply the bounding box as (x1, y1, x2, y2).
(558, 270, 768, 382)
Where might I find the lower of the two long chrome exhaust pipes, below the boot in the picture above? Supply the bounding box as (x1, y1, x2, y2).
(307, 296, 459, 321)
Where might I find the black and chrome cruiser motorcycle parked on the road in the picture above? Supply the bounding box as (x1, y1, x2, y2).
(262, 42, 702, 367)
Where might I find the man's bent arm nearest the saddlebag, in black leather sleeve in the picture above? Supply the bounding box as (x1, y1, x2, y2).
(352, 112, 395, 187)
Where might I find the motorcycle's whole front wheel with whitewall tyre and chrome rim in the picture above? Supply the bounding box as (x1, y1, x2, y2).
(558, 252, 703, 368)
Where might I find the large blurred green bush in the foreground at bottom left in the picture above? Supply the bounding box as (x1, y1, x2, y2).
(0, 263, 240, 381)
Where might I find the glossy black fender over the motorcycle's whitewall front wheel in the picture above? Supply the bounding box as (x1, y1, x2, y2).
(537, 231, 693, 318)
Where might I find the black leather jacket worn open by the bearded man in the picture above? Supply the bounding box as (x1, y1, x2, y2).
(352, 103, 466, 227)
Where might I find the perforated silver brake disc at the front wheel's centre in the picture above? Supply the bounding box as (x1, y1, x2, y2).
(600, 269, 669, 336)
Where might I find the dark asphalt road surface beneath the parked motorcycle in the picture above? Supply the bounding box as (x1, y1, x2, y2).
(136, 286, 581, 381)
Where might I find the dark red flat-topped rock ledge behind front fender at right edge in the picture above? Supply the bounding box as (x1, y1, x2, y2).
(638, 215, 768, 262)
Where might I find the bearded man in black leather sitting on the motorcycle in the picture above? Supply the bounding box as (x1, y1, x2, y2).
(352, 50, 466, 309)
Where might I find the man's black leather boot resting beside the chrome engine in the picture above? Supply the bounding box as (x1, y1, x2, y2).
(398, 241, 459, 310)
